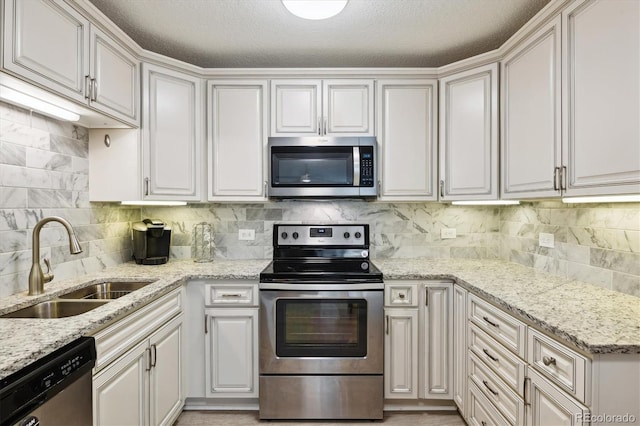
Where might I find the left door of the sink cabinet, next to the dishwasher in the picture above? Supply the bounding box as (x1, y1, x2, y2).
(93, 340, 151, 426)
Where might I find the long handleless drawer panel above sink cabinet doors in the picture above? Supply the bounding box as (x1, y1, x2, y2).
(94, 288, 183, 372)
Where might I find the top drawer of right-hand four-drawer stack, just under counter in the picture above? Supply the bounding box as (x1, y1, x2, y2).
(469, 294, 527, 358)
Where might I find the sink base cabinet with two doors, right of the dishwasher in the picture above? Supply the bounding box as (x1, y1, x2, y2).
(93, 289, 184, 426)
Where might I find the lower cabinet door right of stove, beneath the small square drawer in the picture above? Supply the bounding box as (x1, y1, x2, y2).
(384, 309, 418, 399)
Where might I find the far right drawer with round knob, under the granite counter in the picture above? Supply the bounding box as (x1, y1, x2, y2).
(527, 329, 591, 404)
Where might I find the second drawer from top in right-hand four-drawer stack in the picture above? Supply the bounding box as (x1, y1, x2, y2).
(468, 323, 526, 397)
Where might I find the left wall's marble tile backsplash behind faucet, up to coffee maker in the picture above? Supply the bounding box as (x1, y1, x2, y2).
(0, 102, 140, 297)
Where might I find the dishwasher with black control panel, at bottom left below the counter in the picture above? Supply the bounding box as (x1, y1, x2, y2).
(0, 337, 96, 426)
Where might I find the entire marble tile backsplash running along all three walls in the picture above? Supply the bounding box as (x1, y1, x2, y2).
(0, 103, 640, 297)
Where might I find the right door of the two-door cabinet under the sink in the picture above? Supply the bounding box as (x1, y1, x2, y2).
(149, 315, 184, 425)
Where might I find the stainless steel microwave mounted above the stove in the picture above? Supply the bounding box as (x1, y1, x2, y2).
(267, 137, 378, 198)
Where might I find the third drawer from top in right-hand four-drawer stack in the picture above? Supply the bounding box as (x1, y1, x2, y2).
(469, 352, 524, 426)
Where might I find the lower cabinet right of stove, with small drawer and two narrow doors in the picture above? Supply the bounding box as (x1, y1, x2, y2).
(384, 281, 453, 399)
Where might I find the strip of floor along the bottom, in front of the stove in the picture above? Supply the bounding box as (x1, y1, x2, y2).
(174, 411, 465, 426)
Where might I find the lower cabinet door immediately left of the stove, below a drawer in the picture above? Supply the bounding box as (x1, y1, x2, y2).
(205, 308, 258, 398)
